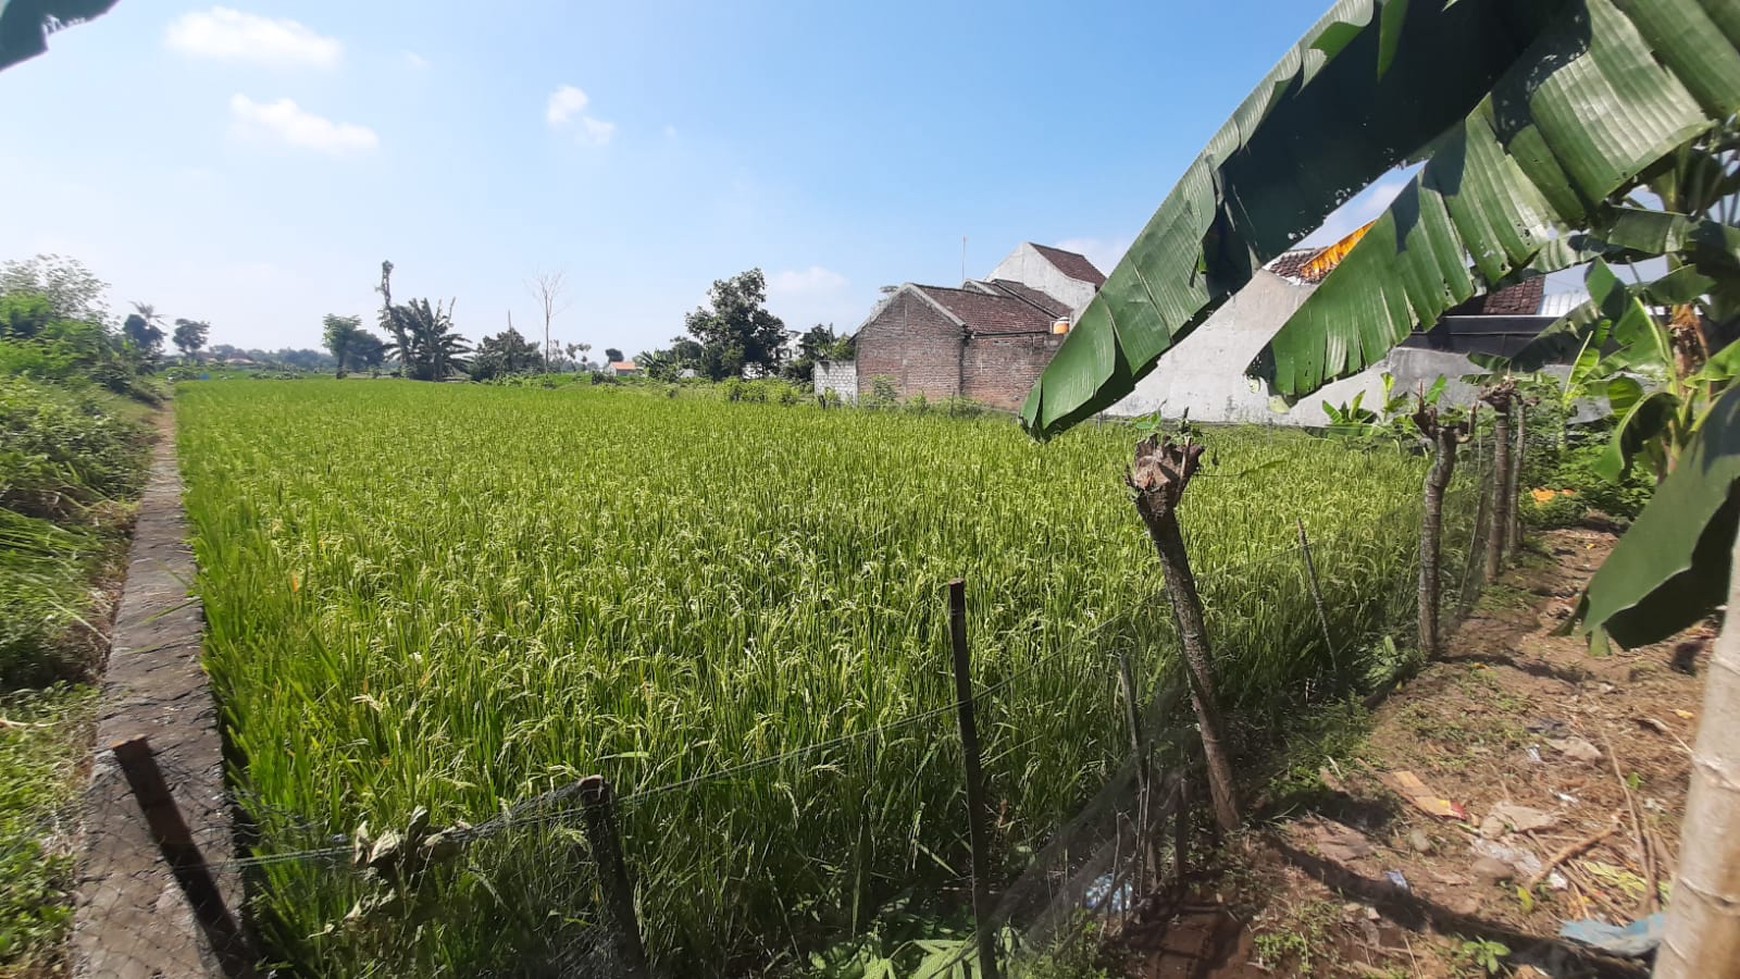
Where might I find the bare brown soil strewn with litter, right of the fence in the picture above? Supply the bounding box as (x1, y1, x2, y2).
(1126, 530, 1716, 979)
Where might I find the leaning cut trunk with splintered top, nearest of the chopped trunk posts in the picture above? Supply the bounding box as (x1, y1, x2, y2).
(1126, 436, 1241, 833)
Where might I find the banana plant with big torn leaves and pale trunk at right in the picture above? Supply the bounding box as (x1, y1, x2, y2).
(1021, 0, 1740, 979)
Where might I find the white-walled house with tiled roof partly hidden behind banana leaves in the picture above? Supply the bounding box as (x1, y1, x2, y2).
(1107, 239, 1554, 426)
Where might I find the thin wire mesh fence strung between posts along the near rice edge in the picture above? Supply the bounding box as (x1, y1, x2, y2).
(71, 438, 1491, 977)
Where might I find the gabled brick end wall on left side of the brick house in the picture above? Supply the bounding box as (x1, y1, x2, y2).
(858, 290, 960, 400)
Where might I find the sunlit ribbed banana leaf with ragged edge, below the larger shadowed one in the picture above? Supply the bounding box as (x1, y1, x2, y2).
(1251, 0, 1740, 398)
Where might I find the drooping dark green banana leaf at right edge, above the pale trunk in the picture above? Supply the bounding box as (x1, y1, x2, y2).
(1575, 388, 1740, 647)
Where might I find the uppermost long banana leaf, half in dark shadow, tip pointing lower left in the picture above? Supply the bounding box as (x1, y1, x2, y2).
(1021, 0, 1576, 436)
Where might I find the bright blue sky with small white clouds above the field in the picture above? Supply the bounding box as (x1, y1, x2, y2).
(0, 0, 1399, 355)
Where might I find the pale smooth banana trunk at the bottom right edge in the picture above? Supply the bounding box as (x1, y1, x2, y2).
(1655, 537, 1740, 979)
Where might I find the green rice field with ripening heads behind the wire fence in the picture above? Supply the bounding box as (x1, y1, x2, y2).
(176, 381, 1467, 976)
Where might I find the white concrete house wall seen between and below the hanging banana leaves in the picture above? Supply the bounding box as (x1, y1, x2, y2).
(1105, 271, 1479, 426)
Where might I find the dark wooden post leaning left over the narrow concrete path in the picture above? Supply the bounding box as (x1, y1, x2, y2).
(110, 737, 259, 979)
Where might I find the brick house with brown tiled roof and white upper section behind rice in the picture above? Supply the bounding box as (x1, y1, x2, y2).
(842, 242, 1105, 410)
